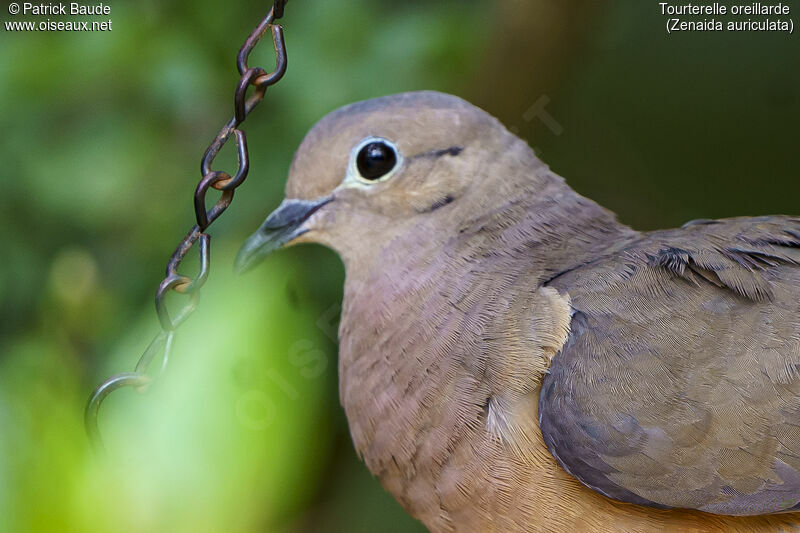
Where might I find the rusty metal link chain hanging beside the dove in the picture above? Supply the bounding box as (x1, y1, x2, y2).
(84, 0, 288, 450)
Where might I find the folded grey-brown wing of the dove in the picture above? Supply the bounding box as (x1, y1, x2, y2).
(539, 217, 800, 515)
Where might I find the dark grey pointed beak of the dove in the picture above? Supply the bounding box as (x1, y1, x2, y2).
(235, 196, 333, 274)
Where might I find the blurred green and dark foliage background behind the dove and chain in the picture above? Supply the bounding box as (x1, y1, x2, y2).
(0, 0, 800, 532)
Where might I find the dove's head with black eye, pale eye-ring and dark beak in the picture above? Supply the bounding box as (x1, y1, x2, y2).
(237, 91, 562, 270)
